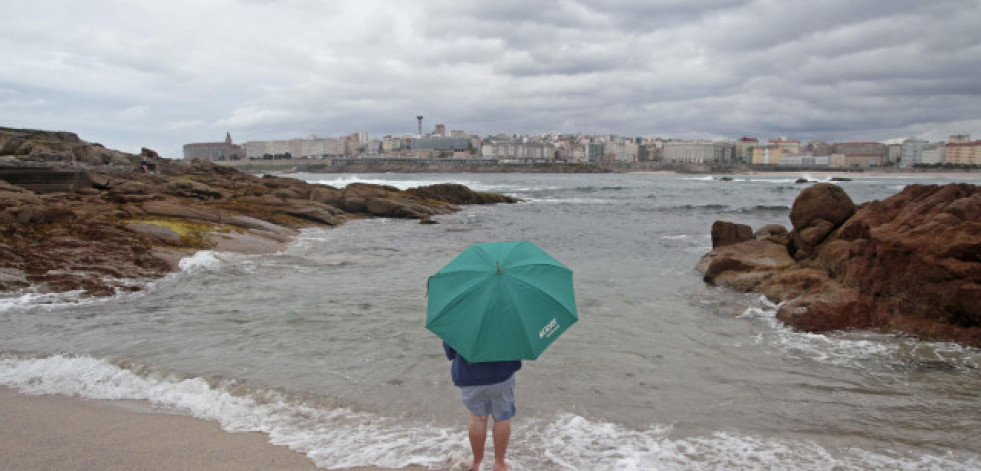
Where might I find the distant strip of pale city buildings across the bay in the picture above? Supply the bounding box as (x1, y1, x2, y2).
(183, 127, 981, 168)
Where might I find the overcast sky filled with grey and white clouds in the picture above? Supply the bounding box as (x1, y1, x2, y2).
(0, 0, 981, 157)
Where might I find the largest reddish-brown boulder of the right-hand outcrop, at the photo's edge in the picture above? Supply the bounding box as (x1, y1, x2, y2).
(824, 184, 981, 327)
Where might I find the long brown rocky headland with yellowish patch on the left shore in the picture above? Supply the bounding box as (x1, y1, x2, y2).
(0, 128, 516, 295)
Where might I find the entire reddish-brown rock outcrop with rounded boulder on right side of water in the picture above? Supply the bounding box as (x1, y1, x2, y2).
(697, 184, 981, 346)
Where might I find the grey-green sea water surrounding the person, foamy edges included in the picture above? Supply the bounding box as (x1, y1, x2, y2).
(0, 174, 981, 470)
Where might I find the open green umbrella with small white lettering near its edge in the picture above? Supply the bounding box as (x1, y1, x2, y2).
(426, 241, 579, 363)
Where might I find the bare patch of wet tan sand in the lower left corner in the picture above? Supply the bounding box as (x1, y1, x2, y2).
(0, 387, 424, 471)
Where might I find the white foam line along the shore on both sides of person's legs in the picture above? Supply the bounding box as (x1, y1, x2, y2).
(0, 354, 981, 471)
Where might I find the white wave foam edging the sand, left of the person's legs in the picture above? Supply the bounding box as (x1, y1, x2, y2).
(0, 355, 465, 468)
